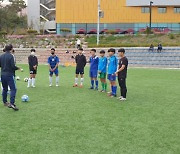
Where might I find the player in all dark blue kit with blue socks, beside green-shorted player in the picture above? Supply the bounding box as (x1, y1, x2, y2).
(89, 49, 99, 90)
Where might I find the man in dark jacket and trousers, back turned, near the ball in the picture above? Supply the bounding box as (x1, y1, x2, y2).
(0, 44, 20, 111)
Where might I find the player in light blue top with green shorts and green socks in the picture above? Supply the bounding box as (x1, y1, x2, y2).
(98, 50, 107, 92)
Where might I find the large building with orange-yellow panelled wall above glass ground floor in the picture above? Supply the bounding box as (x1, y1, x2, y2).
(56, 0, 180, 34)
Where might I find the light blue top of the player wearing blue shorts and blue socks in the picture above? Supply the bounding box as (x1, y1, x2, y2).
(108, 55, 118, 74)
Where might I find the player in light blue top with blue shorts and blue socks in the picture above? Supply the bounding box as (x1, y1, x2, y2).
(108, 48, 118, 97)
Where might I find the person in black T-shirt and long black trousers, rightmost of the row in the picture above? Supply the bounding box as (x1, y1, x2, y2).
(116, 49, 128, 101)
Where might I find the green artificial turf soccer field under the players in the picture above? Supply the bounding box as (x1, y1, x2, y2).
(0, 65, 180, 154)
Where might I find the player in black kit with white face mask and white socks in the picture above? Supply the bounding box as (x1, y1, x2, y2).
(27, 49, 38, 88)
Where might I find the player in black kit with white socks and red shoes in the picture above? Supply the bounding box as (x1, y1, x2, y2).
(73, 48, 86, 88)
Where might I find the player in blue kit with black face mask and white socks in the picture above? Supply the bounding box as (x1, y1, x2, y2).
(48, 48, 60, 87)
